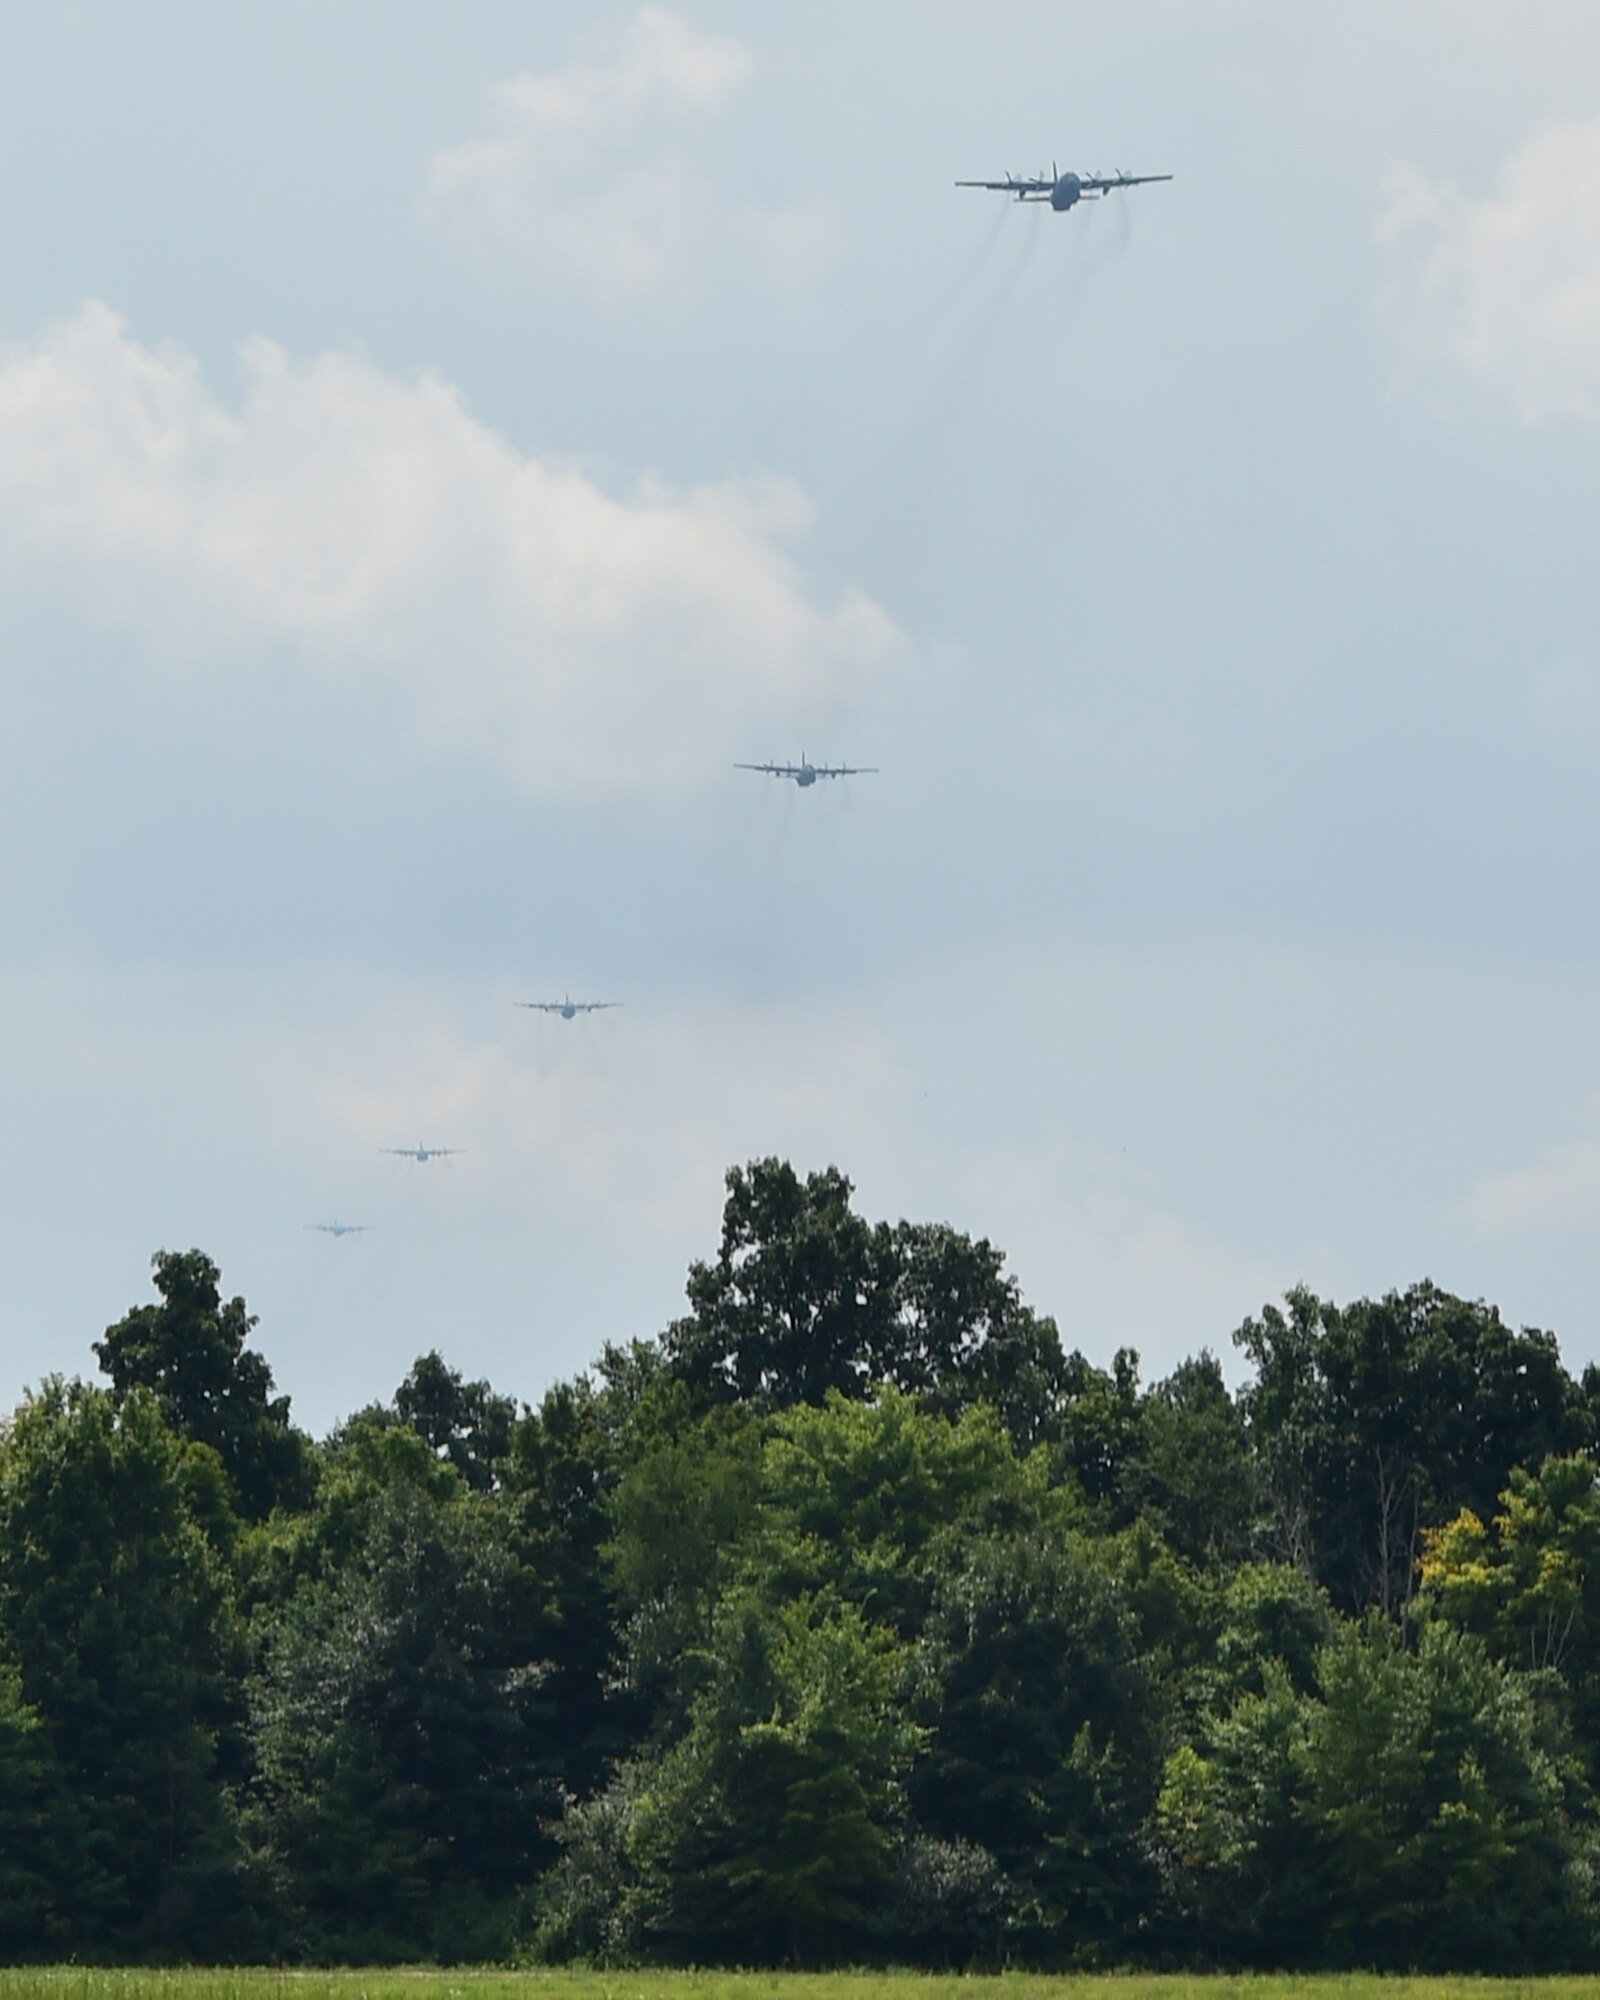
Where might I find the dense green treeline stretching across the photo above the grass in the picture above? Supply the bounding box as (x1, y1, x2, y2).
(0, 1160, 1600, 1970)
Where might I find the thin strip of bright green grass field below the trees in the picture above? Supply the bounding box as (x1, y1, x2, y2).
(0, 1966, 1600, 2000)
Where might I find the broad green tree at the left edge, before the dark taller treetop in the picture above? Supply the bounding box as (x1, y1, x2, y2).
(0, 1380, 248, 1956)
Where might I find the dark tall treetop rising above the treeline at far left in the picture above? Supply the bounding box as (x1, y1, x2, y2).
(94, 1250, 310, 1520)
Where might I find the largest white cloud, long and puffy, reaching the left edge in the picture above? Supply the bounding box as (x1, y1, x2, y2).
(0, 304, 898, 792)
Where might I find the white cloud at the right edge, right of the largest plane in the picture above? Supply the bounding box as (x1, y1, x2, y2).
(1376, 118, 1600, 424)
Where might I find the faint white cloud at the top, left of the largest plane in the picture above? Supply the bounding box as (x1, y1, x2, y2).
(424, 6, 838, 304)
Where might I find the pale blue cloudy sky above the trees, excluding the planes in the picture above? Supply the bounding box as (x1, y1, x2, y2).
(0, 0, 1600, 1430)
